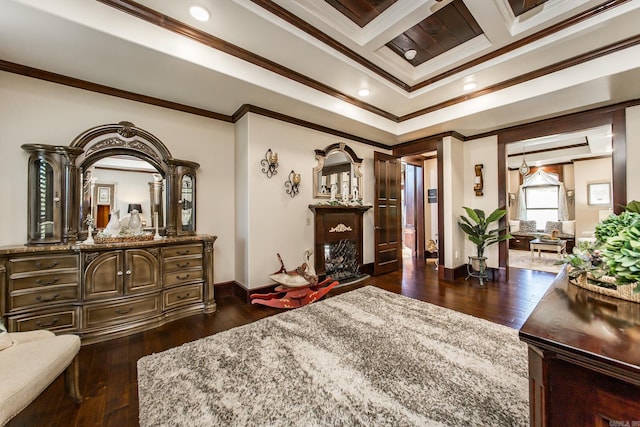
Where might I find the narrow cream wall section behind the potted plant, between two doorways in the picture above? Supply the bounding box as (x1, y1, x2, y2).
(458, 135, 499, 267)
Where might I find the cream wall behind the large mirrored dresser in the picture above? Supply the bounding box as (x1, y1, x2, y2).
(0, 72, 235, 283)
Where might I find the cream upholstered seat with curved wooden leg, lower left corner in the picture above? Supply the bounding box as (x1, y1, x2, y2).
(0, 330, 82, 426)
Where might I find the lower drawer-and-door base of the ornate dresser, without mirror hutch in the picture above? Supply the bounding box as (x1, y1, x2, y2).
(0, 235, 216, 344)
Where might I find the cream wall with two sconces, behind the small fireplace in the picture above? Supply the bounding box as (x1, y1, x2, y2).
(236, 114, 388, 289)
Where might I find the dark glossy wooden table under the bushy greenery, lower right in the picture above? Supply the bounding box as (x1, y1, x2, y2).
(520, 269, 640, 427)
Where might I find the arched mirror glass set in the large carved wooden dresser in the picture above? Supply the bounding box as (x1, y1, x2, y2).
(82, 155, 166, 229)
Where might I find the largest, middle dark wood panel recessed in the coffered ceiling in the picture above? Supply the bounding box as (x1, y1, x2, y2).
(387, 0, 482, 66)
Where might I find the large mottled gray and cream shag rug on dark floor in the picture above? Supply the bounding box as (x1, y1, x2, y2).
(138, 286, 529, 426)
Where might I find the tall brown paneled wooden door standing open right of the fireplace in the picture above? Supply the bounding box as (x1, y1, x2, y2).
(373, 152, 402, 275)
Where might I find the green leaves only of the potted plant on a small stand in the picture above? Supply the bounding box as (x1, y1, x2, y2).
(458, 206, 513, 258)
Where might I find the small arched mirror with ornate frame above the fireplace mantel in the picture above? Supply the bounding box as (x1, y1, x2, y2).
(313, 142, 363, 199)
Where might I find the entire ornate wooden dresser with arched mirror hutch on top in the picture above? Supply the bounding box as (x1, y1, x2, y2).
(0, 121, 216, 343)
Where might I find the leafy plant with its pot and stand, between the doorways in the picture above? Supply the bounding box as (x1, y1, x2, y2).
(458, 206, 513, 285)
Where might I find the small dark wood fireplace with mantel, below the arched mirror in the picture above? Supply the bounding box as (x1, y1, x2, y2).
(309, 205, 370, 283)
